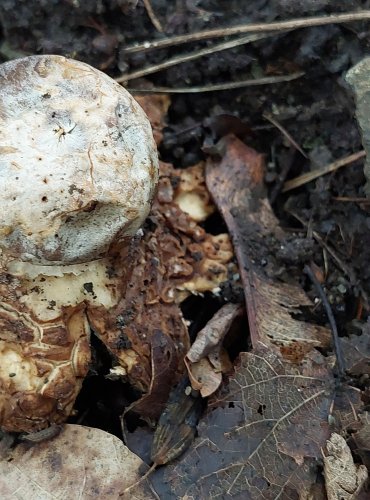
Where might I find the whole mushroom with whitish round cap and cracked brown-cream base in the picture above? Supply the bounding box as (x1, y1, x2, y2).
(0, 55, 158, 431)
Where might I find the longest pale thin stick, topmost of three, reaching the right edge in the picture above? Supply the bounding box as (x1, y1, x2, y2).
(125, 10, 370, 54)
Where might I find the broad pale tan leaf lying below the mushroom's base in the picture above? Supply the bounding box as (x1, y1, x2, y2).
(0, 424, 155, 500)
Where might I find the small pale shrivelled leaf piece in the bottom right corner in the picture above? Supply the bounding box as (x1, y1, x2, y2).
(324, 433, 368, 500)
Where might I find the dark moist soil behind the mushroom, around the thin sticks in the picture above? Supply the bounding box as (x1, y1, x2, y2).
(0, 0, 370, 464)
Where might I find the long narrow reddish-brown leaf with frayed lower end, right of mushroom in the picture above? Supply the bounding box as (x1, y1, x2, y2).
(206, 136, 330, 356)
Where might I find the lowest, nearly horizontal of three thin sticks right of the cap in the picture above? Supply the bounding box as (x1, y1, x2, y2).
(126, 72, 304, 94)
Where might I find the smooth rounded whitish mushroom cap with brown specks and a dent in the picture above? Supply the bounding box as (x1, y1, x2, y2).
(0, 55, 158, 265)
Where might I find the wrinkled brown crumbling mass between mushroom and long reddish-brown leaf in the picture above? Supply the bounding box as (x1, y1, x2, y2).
(88, 162, 237, 404)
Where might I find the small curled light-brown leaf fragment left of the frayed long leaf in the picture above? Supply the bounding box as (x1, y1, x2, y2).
(185, 304, 242, 397)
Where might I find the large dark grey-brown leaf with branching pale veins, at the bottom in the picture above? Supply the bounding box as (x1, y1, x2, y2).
(166, 350, 333, 500)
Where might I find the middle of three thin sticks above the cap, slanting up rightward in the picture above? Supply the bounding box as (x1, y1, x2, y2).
(115, 34, 270, 83)
